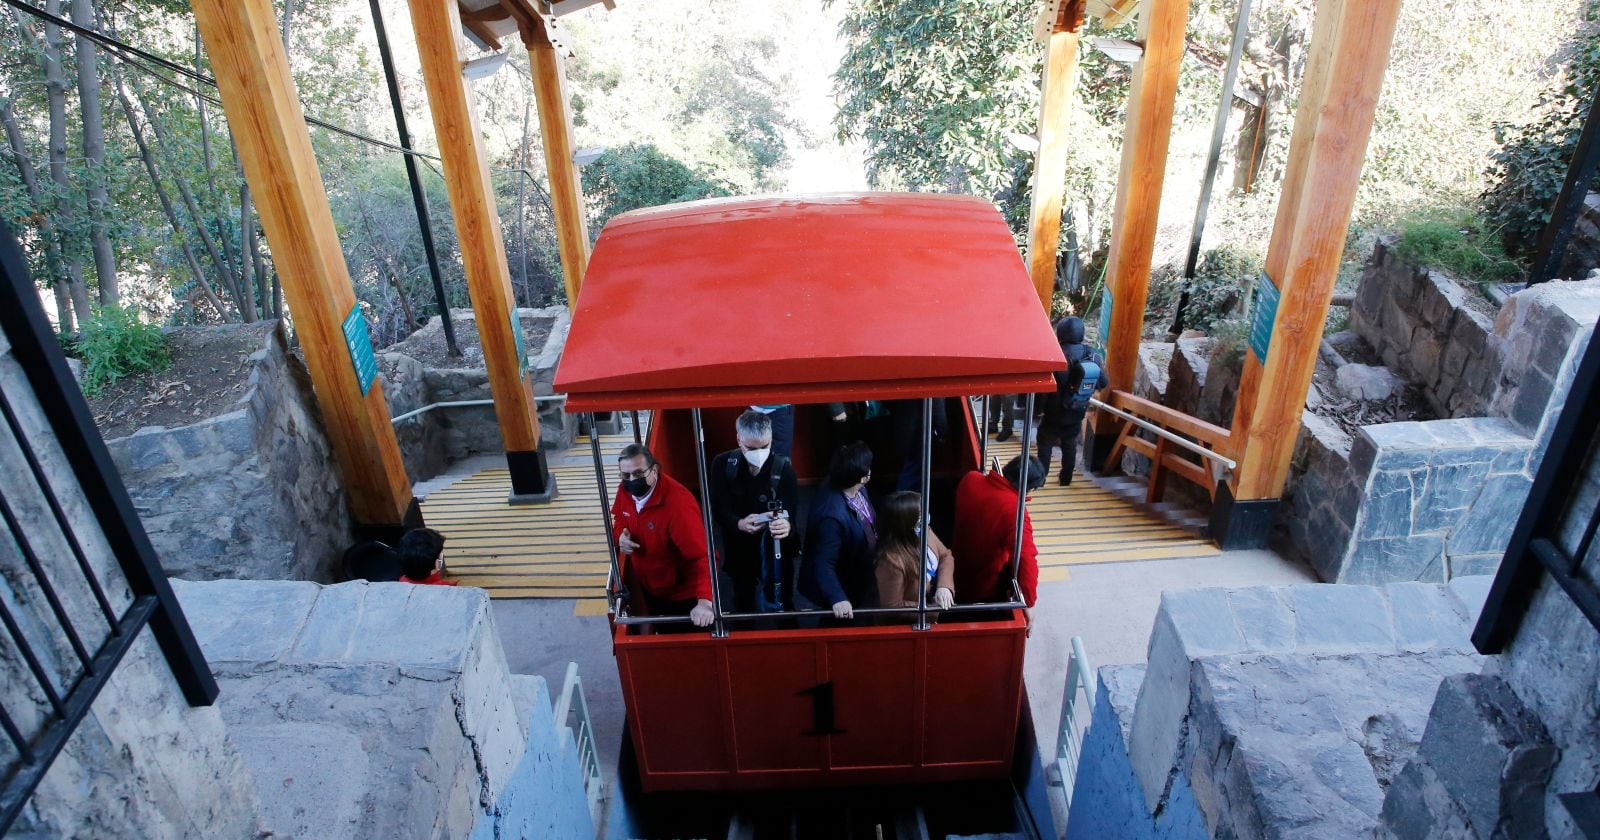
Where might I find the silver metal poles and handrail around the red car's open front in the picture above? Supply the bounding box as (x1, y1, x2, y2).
(589, 394, 1034, 637)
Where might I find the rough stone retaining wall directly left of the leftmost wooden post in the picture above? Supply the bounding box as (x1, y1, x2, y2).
(106, 323, 354, 581)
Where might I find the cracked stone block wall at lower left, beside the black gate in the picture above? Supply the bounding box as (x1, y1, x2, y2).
(176, 581, 594, 838)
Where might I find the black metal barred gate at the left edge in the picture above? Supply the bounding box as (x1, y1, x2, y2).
(0, 222, 218, 834)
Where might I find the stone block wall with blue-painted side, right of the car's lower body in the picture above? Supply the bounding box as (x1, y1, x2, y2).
(1067, 578, 1488, 837)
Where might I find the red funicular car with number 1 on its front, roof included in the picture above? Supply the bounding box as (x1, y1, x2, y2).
(555, 194, 1066, 790)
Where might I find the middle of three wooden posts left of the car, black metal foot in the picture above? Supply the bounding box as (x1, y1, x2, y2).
(410, 0, 555, 502)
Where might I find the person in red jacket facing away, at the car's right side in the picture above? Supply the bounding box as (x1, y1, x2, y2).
(950, 456, 1045, 608)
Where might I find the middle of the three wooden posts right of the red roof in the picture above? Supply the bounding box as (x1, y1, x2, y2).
(1085, 0, 1189, 464)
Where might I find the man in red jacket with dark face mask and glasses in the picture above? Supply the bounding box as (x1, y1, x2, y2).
(611, 443, 712, 627)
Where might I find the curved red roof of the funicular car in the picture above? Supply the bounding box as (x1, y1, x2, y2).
(555, 192, 1066, 411)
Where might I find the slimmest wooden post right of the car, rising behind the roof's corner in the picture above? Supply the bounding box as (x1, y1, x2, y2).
(1027, 0, 1083, 317)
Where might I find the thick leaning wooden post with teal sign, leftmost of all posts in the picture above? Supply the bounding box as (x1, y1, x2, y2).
(194, 0, 421, 538)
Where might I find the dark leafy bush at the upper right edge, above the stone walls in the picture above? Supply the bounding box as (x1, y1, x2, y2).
(1482, 0, 1600, 256)
